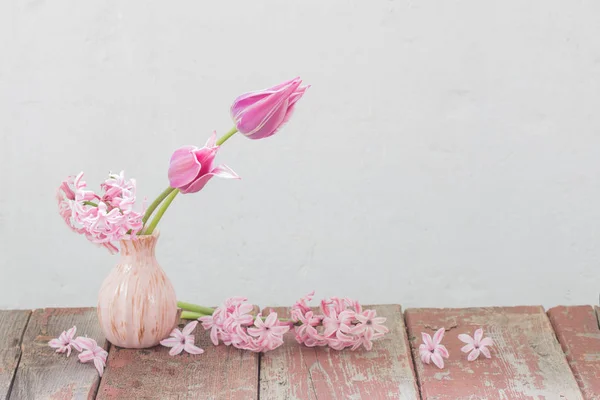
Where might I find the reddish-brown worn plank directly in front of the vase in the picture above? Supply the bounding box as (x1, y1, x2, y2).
(97, 320, 259, 400)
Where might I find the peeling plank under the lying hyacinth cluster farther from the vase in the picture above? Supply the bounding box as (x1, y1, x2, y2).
(260, 305, 419, 400)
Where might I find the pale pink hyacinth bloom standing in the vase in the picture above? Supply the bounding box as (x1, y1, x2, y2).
(57, 171, 143, 253)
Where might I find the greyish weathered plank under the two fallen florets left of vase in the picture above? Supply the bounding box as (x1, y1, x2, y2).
(10, 308, 107, 400)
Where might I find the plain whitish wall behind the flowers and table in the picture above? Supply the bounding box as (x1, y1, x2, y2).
(0, 0, 600, 308)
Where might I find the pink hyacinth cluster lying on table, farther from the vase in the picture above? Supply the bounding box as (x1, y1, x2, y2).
(291, 292, 389, 350)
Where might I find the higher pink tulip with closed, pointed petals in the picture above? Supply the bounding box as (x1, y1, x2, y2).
(231, 78, 309, 139)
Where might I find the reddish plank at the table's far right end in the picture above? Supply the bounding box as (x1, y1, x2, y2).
(548, 306, 600, 400)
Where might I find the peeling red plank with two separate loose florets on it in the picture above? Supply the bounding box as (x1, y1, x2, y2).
(405, 306, 582, 400)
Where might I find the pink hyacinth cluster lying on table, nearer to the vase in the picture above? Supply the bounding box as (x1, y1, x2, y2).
(199, 297, 290, 353)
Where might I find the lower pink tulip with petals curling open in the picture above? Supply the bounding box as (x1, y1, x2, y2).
(169, 132, 240, 194)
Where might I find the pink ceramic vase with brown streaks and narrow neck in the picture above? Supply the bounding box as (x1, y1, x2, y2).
(98, 231, 177, 349)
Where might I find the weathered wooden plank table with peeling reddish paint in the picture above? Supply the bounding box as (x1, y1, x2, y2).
(0, 305, 600, 400)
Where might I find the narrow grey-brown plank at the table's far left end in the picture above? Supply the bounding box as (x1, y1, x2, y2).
(0, 310, 31, 399)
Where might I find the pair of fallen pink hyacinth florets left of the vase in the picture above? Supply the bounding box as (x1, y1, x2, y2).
(48, 326, 108, 376)
